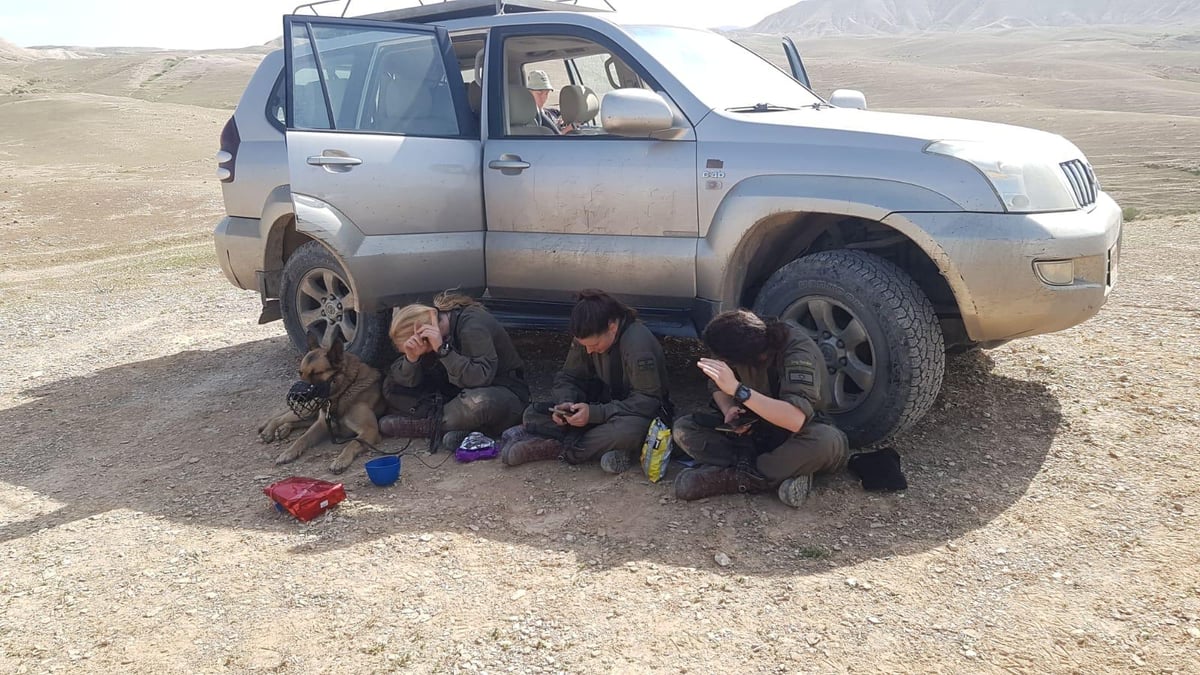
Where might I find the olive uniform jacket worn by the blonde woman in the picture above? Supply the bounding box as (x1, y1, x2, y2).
(391, 305, 529, 400)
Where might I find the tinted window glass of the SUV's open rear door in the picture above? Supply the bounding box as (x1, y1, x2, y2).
(292, 24, 462, 137)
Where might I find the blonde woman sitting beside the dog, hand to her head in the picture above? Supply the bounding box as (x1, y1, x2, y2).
(379, 291, 529, 450)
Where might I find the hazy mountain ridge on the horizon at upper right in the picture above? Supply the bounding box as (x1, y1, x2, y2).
(745, 0, 1200, 36)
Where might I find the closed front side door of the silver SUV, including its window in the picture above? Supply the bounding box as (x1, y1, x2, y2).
(484, 24, 697, 309)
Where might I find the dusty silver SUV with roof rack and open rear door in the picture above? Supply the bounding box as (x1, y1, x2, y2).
(216, 0, 1121, 446)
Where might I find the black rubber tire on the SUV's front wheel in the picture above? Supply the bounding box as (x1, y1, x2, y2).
(755, 250, 946, 448)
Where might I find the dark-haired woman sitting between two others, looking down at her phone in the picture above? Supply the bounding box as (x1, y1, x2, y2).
(500, 291, 668, 473)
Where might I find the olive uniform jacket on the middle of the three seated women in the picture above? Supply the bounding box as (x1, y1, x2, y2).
(553, 321, 668, 424)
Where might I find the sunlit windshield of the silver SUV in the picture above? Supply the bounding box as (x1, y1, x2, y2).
(626, 26, 821, 112)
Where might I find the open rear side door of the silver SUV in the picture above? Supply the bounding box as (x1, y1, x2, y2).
(284, 16, 484, 310)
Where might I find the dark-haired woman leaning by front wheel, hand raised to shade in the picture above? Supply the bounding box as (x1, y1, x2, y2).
(672, 310, 850, 508)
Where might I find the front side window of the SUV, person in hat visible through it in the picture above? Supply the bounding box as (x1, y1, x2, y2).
(503, 35, 643, 138)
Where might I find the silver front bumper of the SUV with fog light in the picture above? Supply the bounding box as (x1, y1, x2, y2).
(884, 193, 1122, 342)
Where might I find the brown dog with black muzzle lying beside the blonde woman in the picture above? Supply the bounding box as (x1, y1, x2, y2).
(258, 335, 386, 473)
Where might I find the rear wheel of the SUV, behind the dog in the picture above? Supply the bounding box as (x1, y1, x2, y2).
(280, 241, 392, 365)
